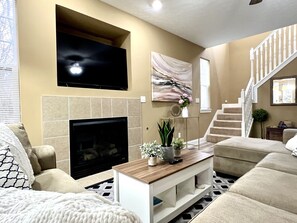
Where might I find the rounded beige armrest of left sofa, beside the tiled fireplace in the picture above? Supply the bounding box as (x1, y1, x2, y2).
(32, 145, 57, 170)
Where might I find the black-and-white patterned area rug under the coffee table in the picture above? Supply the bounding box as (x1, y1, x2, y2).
(86, 172, 237, 223)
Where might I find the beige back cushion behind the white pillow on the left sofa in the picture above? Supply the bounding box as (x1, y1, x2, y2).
(7, 123, 41, 174)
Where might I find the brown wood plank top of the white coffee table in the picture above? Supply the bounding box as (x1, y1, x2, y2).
(112, 150, 213, 184)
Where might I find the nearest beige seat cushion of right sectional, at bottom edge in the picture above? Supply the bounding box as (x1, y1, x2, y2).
(191, 192, 297, 223)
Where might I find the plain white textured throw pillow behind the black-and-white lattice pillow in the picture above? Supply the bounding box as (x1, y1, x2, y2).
(0, 123, 35, 185)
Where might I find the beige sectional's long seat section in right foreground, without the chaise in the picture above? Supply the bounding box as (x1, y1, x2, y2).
(192, 153, 297, 223)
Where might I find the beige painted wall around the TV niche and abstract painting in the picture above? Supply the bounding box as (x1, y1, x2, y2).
(17, 0, 227, 145)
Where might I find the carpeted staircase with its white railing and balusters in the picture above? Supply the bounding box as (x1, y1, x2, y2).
(204, 24, 297, 143)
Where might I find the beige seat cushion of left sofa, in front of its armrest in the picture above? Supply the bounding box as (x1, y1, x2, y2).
(32, 168, 86, 193)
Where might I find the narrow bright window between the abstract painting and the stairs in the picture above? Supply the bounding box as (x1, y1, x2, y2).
(200, 58, 211, 112)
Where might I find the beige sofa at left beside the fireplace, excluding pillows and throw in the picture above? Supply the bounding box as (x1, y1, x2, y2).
(7, 123, 86, 193)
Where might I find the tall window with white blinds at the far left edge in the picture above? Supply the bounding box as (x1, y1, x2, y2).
(0, 0, 20, 123)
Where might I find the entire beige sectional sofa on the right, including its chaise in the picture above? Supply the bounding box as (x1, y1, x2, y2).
(191, 129, 297, 223)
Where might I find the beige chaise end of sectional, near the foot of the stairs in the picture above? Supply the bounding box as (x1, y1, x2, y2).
(214, 137, 290, 163)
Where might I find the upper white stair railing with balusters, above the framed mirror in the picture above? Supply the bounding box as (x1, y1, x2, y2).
(250, 24, 297, 102)
